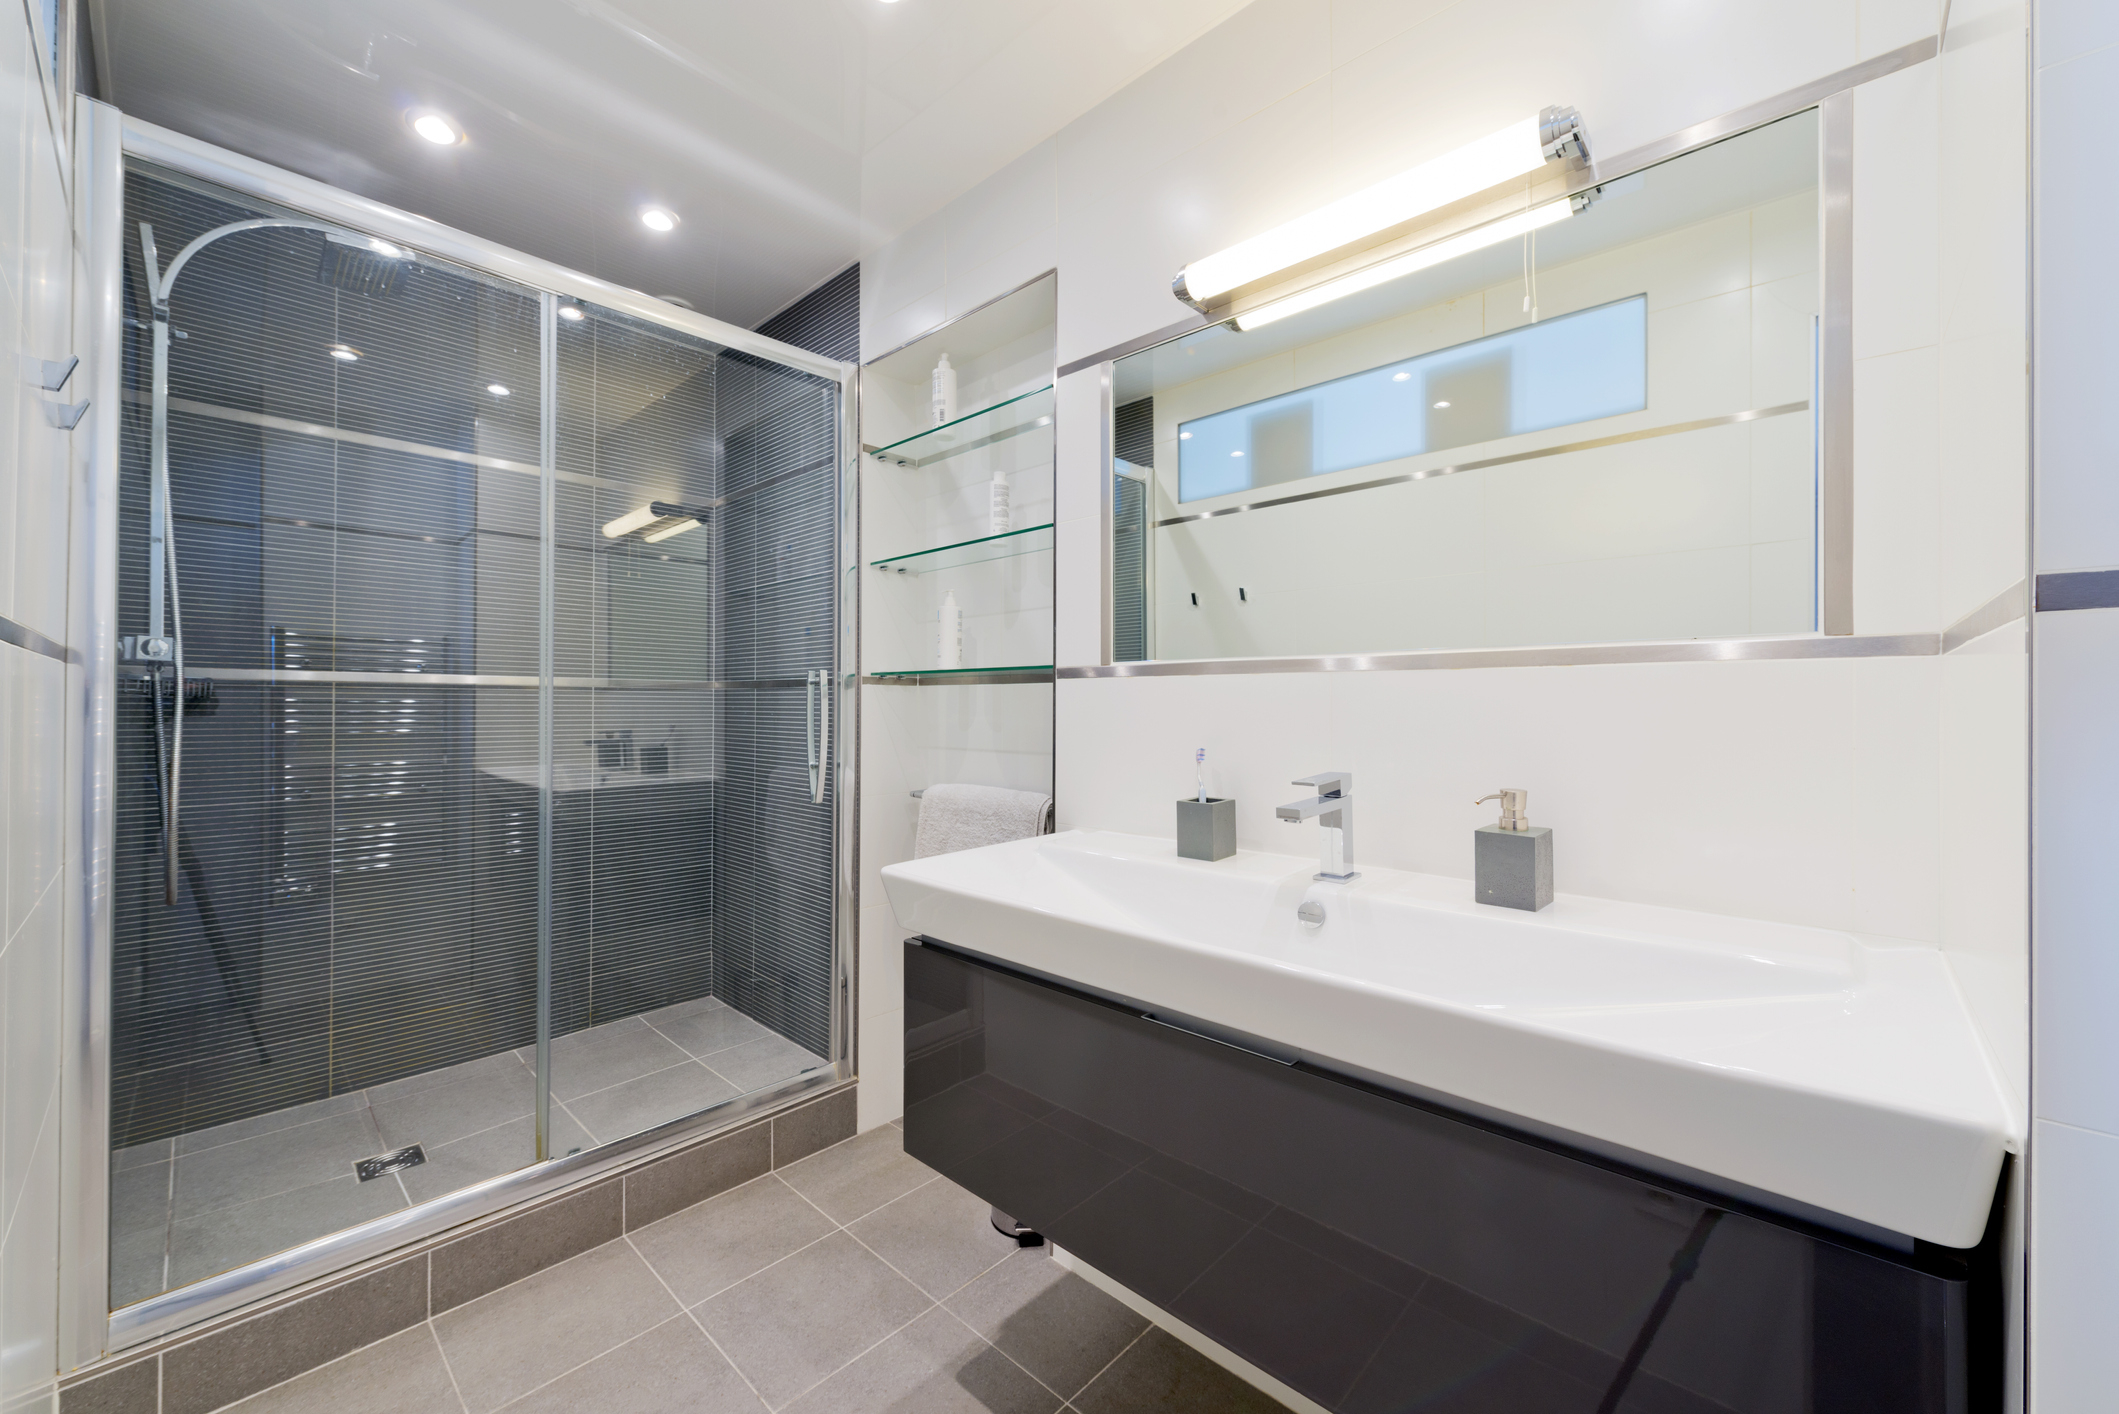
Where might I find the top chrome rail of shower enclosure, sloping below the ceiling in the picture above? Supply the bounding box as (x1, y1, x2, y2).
(123, 117, 854, 382)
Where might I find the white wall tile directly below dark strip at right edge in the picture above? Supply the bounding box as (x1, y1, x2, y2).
(2032, 608, 2119, 1136)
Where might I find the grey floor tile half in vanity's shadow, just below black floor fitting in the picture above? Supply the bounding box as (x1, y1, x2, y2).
(949, 1247, 1148, 1399)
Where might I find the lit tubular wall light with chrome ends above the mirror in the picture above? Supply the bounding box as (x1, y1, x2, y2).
(1174, 108, 1583, 305)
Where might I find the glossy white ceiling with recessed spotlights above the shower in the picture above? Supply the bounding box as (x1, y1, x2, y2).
(89, 0, 1248, 326)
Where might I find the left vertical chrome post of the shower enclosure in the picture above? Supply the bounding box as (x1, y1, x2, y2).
(57, 85, 125, 1369)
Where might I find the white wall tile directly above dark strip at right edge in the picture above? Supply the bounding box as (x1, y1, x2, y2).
(2032, 47, 2119, 572)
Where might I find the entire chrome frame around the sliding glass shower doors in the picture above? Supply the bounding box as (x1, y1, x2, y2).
(59, 98, 860, 1372)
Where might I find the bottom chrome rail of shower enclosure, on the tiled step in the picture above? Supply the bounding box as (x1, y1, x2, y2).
(110, 1064, 852, 1350)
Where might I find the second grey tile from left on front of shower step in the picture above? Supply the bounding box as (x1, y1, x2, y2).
(161, 1255, 428, 1414)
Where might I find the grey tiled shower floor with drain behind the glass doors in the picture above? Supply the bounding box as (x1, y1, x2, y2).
(110, 996, 829, 1306)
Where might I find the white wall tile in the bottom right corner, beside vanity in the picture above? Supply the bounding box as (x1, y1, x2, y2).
(2028, 1121, 2119, 1414)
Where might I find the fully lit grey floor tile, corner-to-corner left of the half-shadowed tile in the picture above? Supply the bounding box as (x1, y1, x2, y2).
(693, 1232, 930, 1408)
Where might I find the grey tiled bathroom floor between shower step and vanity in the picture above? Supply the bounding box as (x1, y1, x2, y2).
(210, 1126, 1284, 1414)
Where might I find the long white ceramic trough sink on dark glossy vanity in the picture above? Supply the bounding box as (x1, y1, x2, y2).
(884, 831, 2017, 1247)
